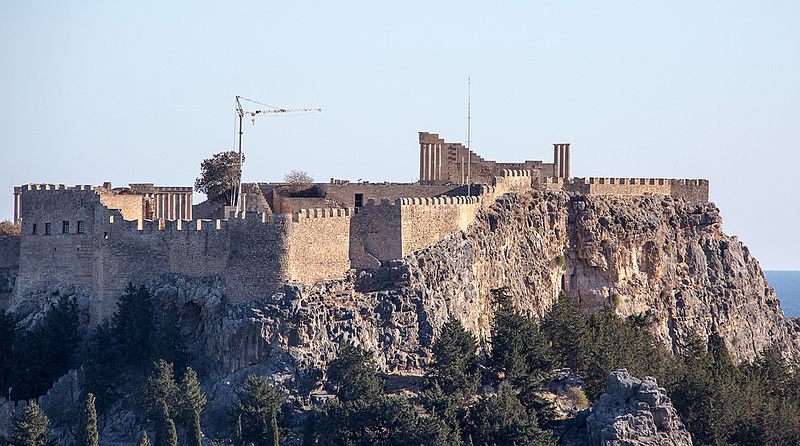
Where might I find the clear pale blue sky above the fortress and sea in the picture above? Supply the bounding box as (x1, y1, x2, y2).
(0, 0, 800, 270)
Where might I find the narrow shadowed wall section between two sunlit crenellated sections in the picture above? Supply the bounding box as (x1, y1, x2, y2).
(350, 199, 403, 268)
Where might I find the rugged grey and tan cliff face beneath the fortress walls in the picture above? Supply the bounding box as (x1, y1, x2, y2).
(4, 191, 800, 438)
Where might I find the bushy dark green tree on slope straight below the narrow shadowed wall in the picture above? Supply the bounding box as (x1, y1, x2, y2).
(328, 342, 383, 401)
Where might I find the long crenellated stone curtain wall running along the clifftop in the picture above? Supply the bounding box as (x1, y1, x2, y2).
(10, 169, 708, 324)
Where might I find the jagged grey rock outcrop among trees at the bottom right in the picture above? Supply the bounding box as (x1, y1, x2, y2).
(586, 369, 692, 446)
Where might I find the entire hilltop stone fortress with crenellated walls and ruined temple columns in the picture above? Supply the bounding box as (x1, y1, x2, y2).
(0, 133, 708, 323)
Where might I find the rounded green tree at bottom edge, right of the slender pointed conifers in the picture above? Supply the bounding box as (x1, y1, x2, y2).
(233, 375, 286, 444)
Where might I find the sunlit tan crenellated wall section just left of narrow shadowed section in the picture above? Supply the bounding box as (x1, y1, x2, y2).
(285, 209, 352, 283)
